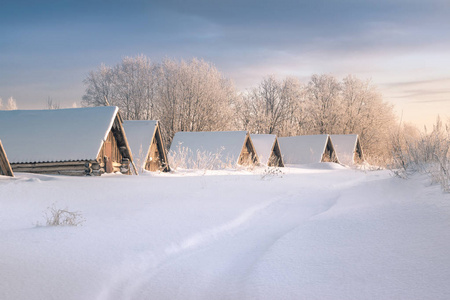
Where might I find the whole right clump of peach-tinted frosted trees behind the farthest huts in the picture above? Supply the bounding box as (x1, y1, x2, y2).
(241, 75, 396, 161)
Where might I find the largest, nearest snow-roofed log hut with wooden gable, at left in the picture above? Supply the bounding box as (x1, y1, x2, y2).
(0, 106, 132, 175)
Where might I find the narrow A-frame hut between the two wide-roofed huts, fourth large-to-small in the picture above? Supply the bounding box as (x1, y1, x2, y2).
(250, 134, 284, 167)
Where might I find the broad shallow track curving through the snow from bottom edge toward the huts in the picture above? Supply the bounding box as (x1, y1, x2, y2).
(99, 190, 339, 300)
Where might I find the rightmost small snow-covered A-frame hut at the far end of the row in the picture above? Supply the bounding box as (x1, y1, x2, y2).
(331, 134, 364, 166)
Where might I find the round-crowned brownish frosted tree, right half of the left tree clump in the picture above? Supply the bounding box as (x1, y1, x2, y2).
(156, 59, 236, 142)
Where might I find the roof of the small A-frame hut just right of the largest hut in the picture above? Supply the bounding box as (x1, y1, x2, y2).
(123, 120, 167, 168)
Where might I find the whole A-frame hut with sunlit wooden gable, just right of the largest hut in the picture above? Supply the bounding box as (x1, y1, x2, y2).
(123, 121, 170, 171)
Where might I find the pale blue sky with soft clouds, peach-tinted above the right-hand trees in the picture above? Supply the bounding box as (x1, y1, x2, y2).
(0, 0, 450, 127)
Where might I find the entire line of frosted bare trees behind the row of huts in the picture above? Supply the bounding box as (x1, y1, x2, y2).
(82, 55, 396, 160)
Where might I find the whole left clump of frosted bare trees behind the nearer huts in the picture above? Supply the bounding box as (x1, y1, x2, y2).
(82, 55, 236, 144)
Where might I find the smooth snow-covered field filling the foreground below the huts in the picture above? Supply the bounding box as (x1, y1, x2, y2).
(0, 164, 450, 300)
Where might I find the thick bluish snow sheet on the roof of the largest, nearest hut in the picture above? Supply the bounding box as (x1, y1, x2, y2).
(0, 106, 118, 163)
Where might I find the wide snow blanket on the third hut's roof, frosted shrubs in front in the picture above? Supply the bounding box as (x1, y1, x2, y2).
(169, 131, 247, 168)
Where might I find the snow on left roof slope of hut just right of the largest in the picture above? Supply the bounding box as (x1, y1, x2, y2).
(123, 120, 158, 167)
